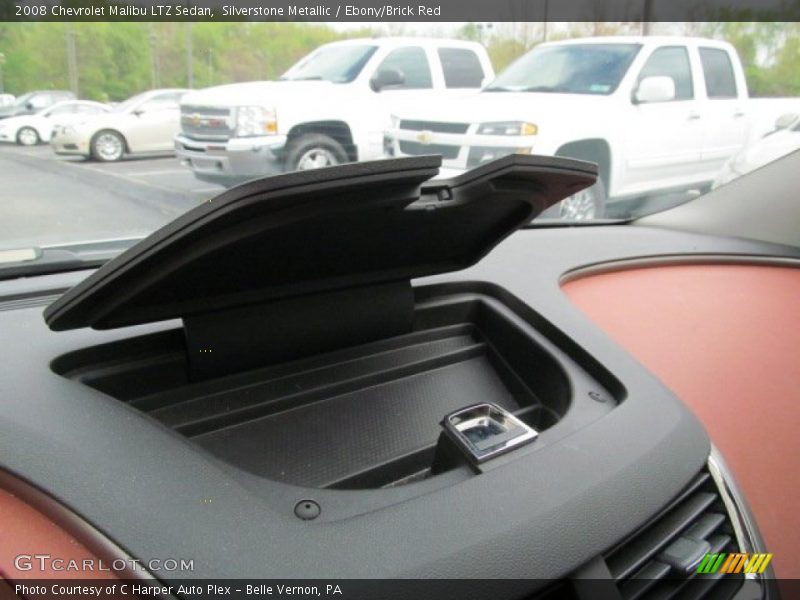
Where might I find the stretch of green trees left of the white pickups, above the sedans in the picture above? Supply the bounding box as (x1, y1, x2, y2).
(0, 22, 372, 101)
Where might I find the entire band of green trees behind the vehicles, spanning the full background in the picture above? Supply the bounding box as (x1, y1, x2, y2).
(0, 21, 800, 101)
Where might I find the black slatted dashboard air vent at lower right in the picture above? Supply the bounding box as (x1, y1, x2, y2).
(605, 470, 744, 600)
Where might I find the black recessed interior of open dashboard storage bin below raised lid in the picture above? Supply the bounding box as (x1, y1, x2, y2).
(54, 293, 570, 489)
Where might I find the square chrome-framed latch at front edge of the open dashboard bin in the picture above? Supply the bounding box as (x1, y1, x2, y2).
(442, 402, 539, 464)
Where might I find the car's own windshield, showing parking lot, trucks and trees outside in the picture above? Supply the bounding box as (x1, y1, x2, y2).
(0, 20, 800, 271)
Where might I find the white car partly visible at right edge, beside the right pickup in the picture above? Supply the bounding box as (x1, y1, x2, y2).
(713, 113, 800, 188)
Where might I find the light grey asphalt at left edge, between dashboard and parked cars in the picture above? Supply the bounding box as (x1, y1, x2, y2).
(0, 144, 223, 248)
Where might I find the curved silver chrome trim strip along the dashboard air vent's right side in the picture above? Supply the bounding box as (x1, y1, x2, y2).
(708, 444, 775, 580)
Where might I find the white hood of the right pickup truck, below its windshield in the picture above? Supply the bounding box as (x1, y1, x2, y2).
(396, 91, 607, 123)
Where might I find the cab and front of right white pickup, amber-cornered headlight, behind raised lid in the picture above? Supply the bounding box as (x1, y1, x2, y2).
(385, 37, 777, 219)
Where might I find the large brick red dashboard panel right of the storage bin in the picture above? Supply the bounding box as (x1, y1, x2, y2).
(563, 264, 800, 579)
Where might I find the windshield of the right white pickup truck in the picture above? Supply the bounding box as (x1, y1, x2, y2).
(486, 44, 641, 94)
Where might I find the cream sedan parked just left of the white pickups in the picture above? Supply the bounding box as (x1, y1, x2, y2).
(50, 89, 188, 162)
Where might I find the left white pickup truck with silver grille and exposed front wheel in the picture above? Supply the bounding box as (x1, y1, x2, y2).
(175, 38, 494, 185)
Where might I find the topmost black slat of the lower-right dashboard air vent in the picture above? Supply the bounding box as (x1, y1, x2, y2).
(607, 492, 718, 581)
